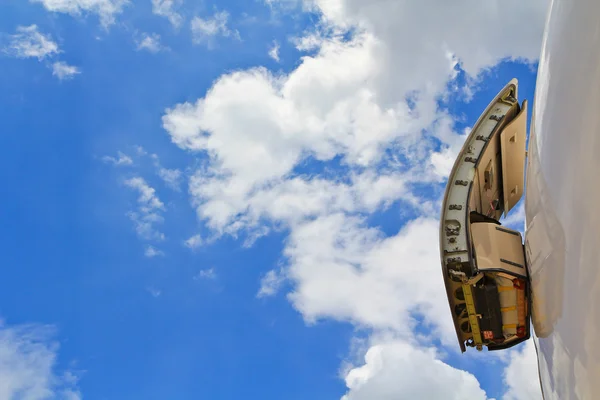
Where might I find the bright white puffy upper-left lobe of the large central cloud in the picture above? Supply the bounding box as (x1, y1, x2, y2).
(163, 40, 418, 169)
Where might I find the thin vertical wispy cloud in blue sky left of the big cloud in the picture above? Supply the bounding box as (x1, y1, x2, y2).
(125, 177, 165, 240)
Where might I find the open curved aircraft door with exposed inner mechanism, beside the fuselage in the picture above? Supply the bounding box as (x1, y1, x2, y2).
(440, 79, 531, 352)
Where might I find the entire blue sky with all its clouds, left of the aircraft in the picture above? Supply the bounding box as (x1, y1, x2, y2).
(0, 0, 546, 400)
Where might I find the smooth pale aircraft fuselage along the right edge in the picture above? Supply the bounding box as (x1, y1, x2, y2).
(525, 0, 600, 400)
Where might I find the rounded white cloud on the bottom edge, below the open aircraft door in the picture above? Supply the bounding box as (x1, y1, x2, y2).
(342, 340, 487, 400)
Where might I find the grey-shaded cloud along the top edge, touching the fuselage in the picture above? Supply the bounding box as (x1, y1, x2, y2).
(278, 0, 548, 78)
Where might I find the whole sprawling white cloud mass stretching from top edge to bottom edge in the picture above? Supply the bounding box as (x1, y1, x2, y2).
(163, 0, 547, 394)
